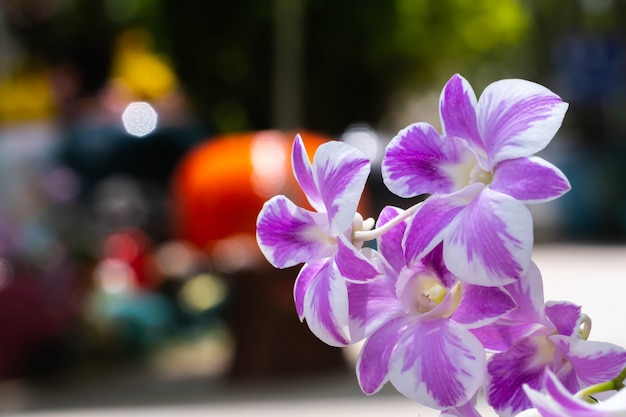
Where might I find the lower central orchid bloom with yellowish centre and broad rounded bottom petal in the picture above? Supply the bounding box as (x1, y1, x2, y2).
(348, 207, 516, 409)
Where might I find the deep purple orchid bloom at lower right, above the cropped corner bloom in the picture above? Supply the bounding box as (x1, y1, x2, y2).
(473, 264, 626, 416)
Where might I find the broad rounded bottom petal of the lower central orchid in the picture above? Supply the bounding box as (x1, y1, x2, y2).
(389, 318, 485, 409)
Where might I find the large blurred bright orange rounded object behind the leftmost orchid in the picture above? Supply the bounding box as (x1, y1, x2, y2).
(168, 130, 330, 264)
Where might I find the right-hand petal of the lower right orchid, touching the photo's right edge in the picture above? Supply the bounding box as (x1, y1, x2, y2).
(550, 335, 626, 388)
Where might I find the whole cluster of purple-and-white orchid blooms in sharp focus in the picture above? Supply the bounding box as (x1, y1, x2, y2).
(257, 74, 626, 417)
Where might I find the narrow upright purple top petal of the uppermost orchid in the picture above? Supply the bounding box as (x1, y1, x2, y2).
(439, 74, 484, 158)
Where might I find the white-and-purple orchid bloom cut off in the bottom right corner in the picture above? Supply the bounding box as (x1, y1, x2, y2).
(517, 371, 626, 417)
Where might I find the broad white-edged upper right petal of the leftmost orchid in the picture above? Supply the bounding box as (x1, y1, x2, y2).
(313, 141, 370, 235)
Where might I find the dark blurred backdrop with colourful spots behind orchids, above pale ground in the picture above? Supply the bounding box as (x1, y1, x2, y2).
(0, 0, 626, 411)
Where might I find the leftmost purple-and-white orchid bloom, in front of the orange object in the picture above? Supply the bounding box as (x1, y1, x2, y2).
(257, 135, 373, 346)
